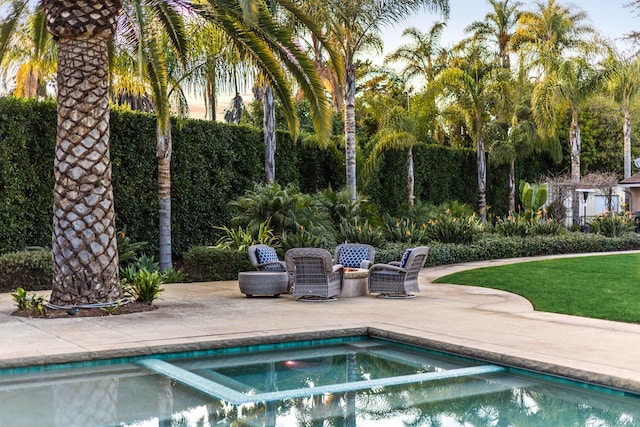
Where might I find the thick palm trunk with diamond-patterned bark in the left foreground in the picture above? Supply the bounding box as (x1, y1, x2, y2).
(44, 0, 122, 306)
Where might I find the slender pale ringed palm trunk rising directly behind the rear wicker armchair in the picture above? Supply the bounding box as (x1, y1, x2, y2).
(344, 64, 357, 203)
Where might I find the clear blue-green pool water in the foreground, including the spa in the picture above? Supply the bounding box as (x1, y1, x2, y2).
(0, 337, 640, 427)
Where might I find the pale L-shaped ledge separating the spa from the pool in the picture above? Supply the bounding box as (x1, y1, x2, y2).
(136, 358, 504, 405)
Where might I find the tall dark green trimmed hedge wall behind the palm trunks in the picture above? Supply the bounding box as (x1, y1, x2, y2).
(0, 98, 552, 255)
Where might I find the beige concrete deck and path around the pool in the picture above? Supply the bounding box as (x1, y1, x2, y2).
(0, 254, 640, 393)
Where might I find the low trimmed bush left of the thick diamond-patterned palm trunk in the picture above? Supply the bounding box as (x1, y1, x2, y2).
(0, 250, 53, 293)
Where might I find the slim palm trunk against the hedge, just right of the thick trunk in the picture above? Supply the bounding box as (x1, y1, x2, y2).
(156, 123, 173, 271)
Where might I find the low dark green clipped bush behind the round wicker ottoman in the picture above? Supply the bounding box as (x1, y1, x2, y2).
(184, 246, 254, 282)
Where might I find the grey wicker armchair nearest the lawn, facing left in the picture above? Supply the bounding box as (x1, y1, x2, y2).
(369, 246, 429, 298)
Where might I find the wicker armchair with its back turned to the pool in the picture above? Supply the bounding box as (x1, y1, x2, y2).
(284, 248, 343, 301)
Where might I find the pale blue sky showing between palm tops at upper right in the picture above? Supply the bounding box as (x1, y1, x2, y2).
(383, 0, 640, 59)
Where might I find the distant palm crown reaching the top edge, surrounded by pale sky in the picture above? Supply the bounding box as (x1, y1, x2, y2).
(464, 0, 522, 68)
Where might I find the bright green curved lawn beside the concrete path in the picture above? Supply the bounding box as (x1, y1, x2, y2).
(436, 253, 640, 323)
